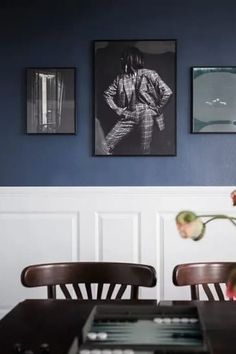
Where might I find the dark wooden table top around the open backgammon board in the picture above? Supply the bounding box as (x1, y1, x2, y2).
(0, 299, 236, 354)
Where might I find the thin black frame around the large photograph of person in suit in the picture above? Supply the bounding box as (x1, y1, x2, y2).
(92, 38, 177, 157)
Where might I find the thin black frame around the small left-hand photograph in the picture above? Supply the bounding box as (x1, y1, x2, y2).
(25, 67, 77, 135)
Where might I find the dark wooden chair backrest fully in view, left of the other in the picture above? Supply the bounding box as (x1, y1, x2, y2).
(21, 262, 156, 300)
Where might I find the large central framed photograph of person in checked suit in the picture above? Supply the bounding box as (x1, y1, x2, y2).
(94, 39, 176, 156)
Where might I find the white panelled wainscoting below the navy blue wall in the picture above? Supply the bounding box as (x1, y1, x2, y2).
(0, 187, 236, 316)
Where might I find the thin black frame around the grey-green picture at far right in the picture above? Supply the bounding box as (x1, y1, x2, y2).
(190, 65, 236, 134)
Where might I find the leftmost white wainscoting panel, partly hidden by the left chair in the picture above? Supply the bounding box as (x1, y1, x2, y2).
(0, 210, 78, 312)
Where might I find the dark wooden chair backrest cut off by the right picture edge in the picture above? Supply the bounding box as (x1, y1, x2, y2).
(173, 262, 236, 301)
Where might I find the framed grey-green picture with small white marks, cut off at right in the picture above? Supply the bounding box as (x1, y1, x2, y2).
(191, 66, 236, 133)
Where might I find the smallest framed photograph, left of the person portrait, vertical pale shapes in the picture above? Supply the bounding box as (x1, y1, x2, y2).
(26, 68, 76, 134)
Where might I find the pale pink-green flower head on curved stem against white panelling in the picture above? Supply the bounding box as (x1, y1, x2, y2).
(176, 211, 205, 241)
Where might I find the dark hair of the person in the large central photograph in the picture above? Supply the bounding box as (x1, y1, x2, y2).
(121, 47, 144, 74)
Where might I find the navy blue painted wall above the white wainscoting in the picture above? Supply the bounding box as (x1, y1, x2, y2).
(0, 0, 236, 186)
